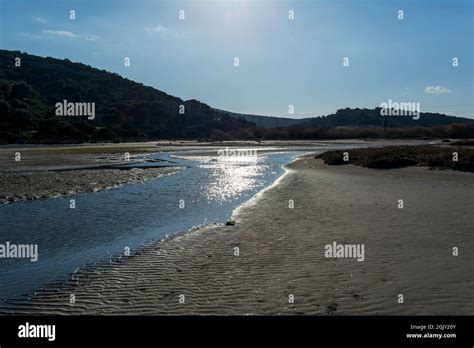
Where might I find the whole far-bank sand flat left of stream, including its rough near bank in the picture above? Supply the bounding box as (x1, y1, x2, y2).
(0, 140, 430, 204)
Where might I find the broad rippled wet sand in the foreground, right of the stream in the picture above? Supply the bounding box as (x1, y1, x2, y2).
(8, 157, 474, 315)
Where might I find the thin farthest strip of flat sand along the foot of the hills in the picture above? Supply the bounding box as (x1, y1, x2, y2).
(0, 139, 426, 173)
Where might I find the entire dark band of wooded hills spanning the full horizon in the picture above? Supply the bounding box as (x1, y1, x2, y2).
(0, 50, 474, 144)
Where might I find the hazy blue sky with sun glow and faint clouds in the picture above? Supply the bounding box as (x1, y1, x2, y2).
(0, 0, 474, 118)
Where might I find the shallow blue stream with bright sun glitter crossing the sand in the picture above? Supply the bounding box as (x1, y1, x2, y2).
(0, 151, 310, 299)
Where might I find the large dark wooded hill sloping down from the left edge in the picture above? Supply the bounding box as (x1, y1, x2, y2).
(0, 50, 252, 143)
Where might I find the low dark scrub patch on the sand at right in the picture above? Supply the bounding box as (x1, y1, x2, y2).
(316, 145, 474, 172)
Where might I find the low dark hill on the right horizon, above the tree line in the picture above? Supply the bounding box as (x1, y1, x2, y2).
(300, 108, 474, 128)
